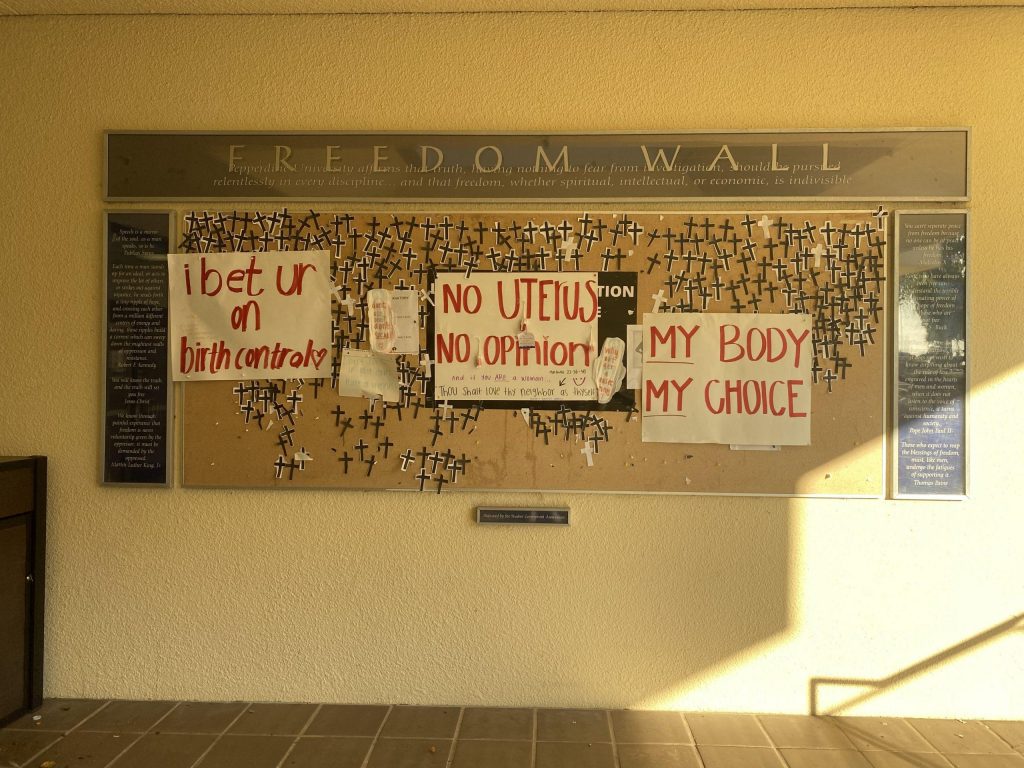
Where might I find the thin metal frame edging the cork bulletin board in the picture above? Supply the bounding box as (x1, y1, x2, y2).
(180, 207, 892, 506)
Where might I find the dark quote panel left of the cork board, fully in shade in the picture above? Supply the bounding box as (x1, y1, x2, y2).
(103, 211, 171, 485)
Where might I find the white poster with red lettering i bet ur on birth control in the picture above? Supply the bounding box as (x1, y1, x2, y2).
(168, 251, 333, 381)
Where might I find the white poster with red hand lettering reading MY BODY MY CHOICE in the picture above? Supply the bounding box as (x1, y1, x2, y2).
(642, 312, 814, 445)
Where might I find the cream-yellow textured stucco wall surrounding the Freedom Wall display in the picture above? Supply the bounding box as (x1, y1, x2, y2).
(0, 8, 1024, 718)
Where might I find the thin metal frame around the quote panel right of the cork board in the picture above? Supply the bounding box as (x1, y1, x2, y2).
(887, 208, 973, 502)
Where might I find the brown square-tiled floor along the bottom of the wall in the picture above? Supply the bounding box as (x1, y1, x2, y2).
(0, 699, 1024, 768)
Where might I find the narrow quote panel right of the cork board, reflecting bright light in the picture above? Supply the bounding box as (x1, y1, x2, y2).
(896, 212, 967, 497)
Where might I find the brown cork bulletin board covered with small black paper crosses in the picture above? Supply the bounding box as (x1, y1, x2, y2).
(178, 205, 889, 497)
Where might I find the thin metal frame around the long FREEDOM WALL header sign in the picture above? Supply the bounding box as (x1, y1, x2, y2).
(103, 126, 972, 207)
